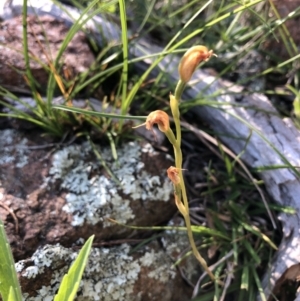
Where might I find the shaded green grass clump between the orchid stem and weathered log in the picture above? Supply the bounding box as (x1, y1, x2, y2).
(191, 146, 276, 301)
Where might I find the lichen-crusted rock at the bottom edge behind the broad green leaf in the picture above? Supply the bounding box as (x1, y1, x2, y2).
(16, 242, 191, 301)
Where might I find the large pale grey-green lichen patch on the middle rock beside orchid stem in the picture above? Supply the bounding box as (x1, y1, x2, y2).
(47, 142, 173, 227)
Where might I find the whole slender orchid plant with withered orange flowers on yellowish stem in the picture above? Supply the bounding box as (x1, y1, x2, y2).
(136, 45, 220, 283)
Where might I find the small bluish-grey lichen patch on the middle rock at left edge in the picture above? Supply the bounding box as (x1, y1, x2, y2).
(0, 129, 28, 168)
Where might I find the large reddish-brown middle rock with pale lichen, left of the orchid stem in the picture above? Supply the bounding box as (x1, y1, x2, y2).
(0, 129, 176, 260)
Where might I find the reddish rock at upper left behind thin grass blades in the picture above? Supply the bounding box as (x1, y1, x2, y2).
(0, 15, 95, 93)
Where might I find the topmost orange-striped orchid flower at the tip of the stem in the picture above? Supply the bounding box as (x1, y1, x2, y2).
(178, 45, 215, 83)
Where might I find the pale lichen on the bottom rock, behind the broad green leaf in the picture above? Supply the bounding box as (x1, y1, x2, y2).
(16, 244, 176, 301)
